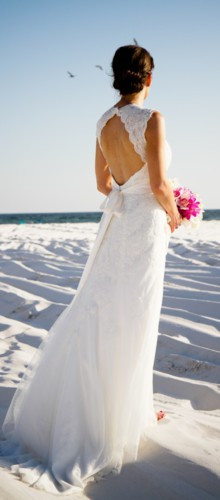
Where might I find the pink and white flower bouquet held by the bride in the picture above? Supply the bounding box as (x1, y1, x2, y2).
(167, 179, 204, 227)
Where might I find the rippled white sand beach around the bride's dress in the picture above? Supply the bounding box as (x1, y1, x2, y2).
(0, 221, 220, 500)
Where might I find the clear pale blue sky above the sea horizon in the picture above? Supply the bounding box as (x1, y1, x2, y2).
(0, 0, 220, 213)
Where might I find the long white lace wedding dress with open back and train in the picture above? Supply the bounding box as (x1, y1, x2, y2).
(0, 104, 171, 494)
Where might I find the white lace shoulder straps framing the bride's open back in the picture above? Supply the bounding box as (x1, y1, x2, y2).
(96, 104, 154, 162)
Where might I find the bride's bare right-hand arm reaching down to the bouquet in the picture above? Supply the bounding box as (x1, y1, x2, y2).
(145, 111, 181, 232)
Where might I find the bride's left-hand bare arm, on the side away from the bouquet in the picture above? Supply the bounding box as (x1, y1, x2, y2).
(95, 139, 112, 196)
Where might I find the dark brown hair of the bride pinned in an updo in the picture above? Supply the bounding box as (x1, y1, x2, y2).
(111, 45, 154, 95)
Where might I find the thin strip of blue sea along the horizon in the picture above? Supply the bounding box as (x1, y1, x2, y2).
(0, 209, 220, 224)
